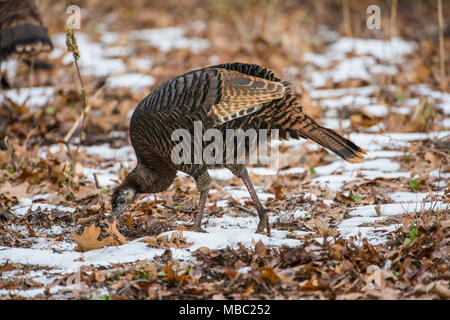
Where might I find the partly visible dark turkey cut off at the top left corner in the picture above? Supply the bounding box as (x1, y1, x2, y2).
(0, 0, 53, 83)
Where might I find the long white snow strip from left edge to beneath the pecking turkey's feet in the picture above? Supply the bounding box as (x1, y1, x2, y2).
(0, 212, 300, 272)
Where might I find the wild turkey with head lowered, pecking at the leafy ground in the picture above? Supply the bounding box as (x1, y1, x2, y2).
(111, 63, 366, 234)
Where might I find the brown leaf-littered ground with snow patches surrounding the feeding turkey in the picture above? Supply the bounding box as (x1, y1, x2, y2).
(0, 0, 450, 299)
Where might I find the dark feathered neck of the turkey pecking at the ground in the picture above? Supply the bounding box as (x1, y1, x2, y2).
(124, 162, 176, 193)
